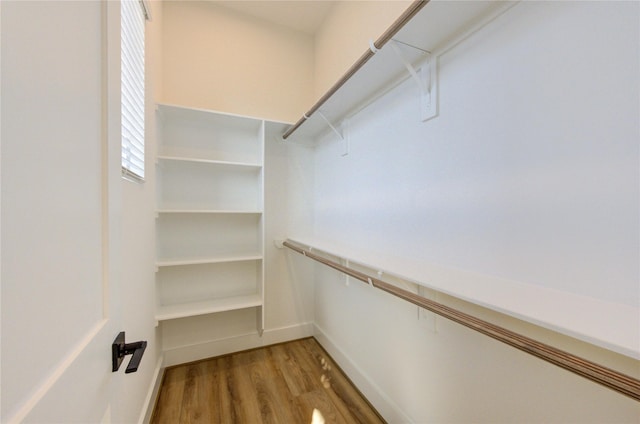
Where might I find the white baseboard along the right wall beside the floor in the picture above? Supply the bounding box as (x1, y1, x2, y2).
(313, 324, 413, 423)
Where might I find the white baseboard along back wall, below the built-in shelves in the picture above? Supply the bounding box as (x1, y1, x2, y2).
(164, 323, 313, 367)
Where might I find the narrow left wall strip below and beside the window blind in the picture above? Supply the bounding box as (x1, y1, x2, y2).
(111, 1, 163, 422)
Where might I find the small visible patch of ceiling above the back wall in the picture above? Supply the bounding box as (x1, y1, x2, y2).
(215, 0, 335, 34)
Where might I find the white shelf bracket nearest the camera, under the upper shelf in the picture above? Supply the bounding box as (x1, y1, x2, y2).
(389, 40, 438, 122)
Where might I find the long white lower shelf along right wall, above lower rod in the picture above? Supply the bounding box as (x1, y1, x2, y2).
(290, 237, 640, 359)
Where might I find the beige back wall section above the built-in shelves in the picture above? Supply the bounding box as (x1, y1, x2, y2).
(161, 1, 313, 122)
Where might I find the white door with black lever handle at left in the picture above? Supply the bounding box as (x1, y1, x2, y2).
(0, 1, 130, 423)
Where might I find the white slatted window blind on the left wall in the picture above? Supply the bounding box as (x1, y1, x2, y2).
(120, 0, 146, 181)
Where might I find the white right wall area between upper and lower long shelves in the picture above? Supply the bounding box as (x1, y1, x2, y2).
(316, 0, 640, 307)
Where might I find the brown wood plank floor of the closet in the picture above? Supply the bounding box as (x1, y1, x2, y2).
(151, 338, 384, 424)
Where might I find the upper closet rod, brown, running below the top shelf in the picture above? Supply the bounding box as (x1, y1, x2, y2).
(282, 0, 429, 140)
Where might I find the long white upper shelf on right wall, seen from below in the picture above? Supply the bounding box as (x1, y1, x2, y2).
(289, 0, 516, 142)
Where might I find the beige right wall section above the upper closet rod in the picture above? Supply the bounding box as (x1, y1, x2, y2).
(314, 0, 411, 97)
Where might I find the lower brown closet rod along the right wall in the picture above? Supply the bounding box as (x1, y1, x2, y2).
(283, 240, 640, 401)
